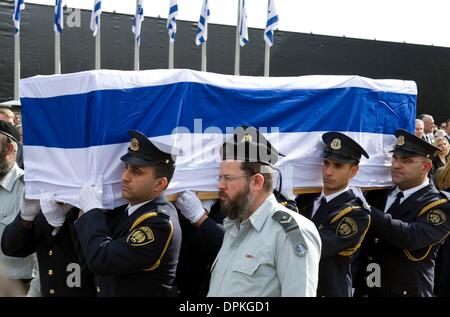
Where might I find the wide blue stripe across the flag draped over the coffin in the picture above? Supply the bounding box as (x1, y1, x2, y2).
(21, 82, 416, 148)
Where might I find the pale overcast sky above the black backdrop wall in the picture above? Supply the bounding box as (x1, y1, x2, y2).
(25, 0, 450, 47)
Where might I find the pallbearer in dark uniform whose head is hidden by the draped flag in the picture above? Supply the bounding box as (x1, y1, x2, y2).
(1, 199, 95, 297)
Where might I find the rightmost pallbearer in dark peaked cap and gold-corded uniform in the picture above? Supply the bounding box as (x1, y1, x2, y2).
(355, 129, 450, 296)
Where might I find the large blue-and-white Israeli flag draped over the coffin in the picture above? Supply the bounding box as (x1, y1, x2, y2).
(20, 69, 417, 208)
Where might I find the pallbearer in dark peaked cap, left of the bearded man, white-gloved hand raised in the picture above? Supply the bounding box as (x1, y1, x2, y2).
(75, 131, 181, 296)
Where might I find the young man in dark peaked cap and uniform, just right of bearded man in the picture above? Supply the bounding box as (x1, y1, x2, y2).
(296, 132, 370, 297)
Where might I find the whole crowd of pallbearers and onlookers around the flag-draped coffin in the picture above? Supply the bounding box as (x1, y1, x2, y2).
(0, 110, 450, 297)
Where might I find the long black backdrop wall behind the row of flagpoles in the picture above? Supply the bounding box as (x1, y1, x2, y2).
(0, 0, 450, 123)
